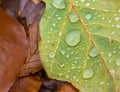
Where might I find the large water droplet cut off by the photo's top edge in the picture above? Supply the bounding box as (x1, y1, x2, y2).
(52, 0, 66, 9)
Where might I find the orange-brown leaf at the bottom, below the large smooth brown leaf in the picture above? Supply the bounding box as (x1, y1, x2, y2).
(10, 74, 42, 92)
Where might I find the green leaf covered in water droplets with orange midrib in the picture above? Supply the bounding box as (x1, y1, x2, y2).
(39, 0, 120, 92)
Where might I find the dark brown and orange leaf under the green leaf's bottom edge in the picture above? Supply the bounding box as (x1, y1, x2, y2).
(39, 79, 79, 92)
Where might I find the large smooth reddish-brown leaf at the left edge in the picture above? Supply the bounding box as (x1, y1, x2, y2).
(0, 8, 28, 92)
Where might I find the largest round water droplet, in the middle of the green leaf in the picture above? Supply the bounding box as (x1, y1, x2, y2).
(65, 30, 81, 46)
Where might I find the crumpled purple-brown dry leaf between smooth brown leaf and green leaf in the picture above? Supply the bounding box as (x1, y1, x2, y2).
(18, 0, 45, 76)
